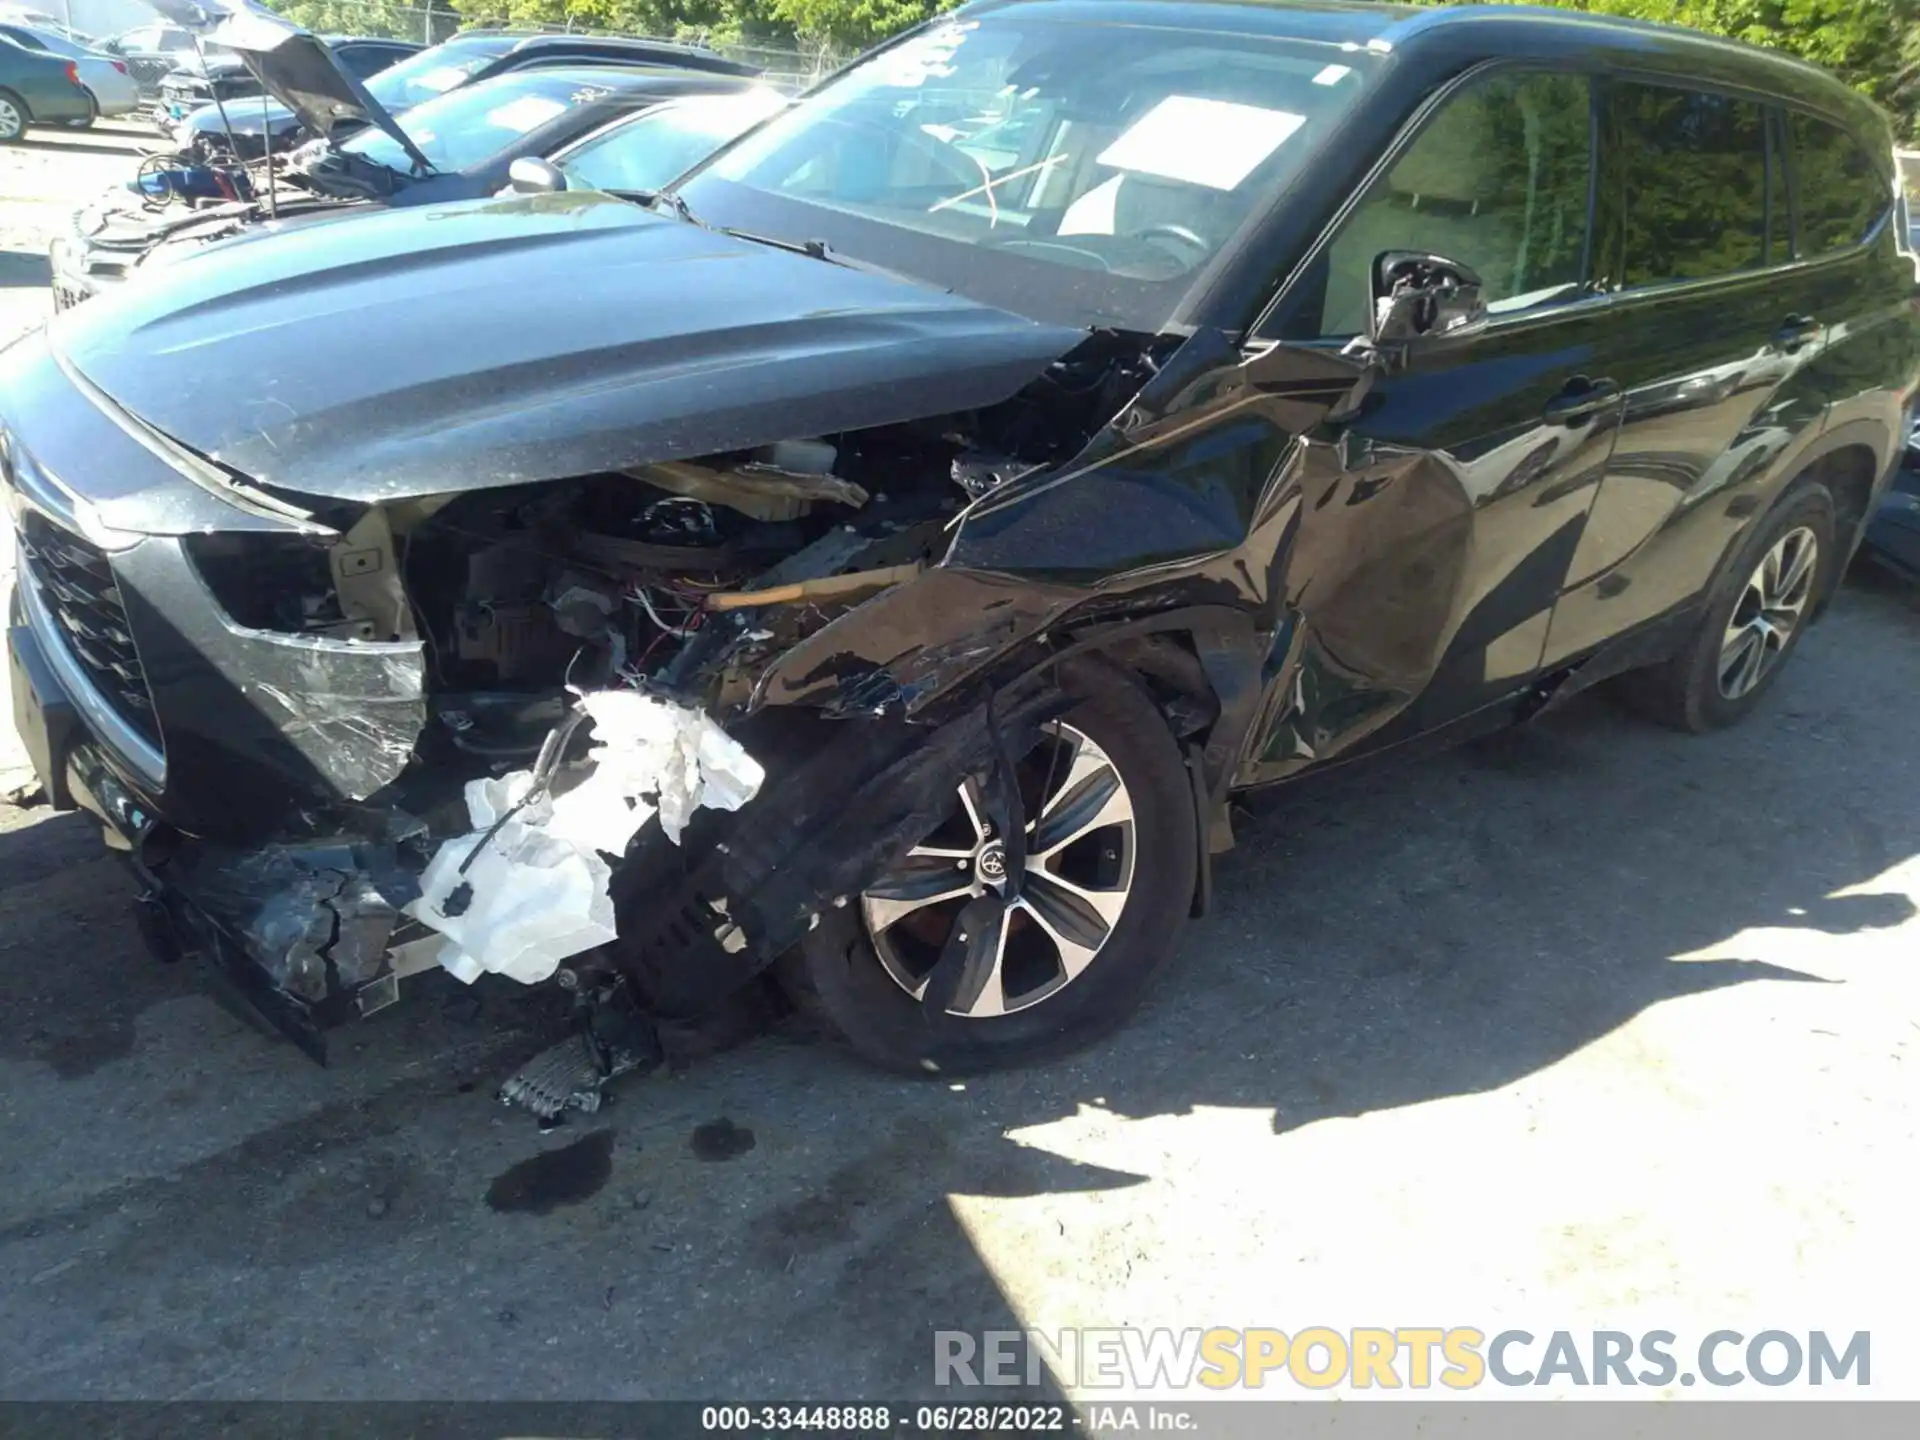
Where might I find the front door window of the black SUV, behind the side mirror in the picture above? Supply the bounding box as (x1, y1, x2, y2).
(1284, 73, 1592, 338)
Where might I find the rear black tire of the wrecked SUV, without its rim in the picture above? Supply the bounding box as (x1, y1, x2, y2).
(1619, 476, 1839, 733)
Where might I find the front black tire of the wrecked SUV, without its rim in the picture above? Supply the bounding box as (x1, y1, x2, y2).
(776, 664, 1196, 1075)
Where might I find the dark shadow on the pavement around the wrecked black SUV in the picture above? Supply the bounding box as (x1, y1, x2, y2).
(0, 591, 1920, 1400)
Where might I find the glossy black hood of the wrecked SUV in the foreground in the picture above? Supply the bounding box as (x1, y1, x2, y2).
(50, 192, 1085, 501)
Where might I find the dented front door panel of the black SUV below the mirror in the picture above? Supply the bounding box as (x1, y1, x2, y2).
(1240, 305, 1619, 783)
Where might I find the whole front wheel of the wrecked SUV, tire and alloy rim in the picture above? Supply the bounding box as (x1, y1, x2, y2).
(780, 666, 1196, 1073)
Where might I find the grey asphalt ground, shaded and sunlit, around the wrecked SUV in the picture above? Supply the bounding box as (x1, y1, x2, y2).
(0, 126, 1920, 1400)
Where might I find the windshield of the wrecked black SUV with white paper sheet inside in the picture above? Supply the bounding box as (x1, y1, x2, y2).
(682, 8, 1371, 330)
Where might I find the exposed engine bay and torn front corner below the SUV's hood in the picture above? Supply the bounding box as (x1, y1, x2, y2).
(131, 336, 1150, 1117)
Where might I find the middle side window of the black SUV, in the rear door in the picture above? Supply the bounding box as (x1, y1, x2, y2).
(1603, 83, 1788, 288)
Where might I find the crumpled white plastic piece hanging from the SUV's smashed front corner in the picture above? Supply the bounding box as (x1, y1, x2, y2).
(407, 689, 766, 985)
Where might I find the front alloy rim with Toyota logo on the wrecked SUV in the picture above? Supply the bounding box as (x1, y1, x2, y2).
(860, 722, 1135, 1020)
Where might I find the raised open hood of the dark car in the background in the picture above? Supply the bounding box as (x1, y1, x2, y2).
(152, 0, 432, 171)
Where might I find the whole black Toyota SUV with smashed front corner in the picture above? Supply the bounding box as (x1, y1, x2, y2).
(0, 0, 1920, 1112)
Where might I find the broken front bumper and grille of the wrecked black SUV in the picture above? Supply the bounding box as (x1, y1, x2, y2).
(0, 357, 426, 1054)
